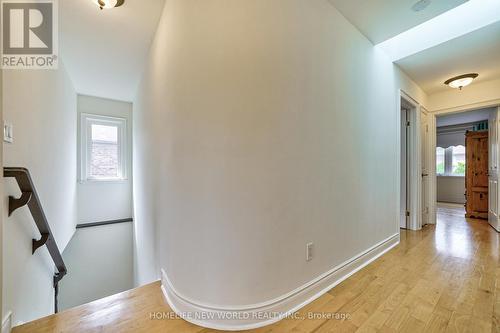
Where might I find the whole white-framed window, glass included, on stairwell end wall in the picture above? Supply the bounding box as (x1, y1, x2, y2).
(80, 114, 127, 181)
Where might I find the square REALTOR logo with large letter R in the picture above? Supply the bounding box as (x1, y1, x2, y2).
(1, 0, 58, 69)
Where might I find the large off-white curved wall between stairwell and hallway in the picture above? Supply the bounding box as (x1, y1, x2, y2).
(134, 0, 425, 329)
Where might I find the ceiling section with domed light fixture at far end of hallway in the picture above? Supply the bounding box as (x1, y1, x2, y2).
(396, 22, 500, 94)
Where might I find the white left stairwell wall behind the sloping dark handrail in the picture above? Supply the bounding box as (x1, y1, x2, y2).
(3, 62, 77, 324)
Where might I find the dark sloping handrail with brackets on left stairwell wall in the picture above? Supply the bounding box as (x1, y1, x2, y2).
(3, 167, 68, 313)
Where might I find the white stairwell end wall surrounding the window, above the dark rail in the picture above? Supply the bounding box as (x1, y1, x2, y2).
(78, 95, 132, 223)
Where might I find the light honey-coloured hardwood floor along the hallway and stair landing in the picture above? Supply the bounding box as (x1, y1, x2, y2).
(14, 207, 500, 333)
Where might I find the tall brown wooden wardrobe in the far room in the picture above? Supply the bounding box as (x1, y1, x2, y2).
(465, 131, 492, 219)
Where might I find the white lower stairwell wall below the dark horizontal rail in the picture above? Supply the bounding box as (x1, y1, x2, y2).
(59, 223, 134, 310)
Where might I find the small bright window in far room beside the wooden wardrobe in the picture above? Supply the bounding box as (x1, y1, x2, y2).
(436, 145, 465, 176)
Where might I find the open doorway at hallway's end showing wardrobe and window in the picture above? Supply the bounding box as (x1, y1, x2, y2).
(431, 107, 500, 230)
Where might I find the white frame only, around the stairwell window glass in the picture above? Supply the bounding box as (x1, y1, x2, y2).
(80, 113, 128, 183)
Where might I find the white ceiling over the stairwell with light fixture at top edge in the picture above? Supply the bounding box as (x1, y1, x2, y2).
(59, 0, 165, 101)
